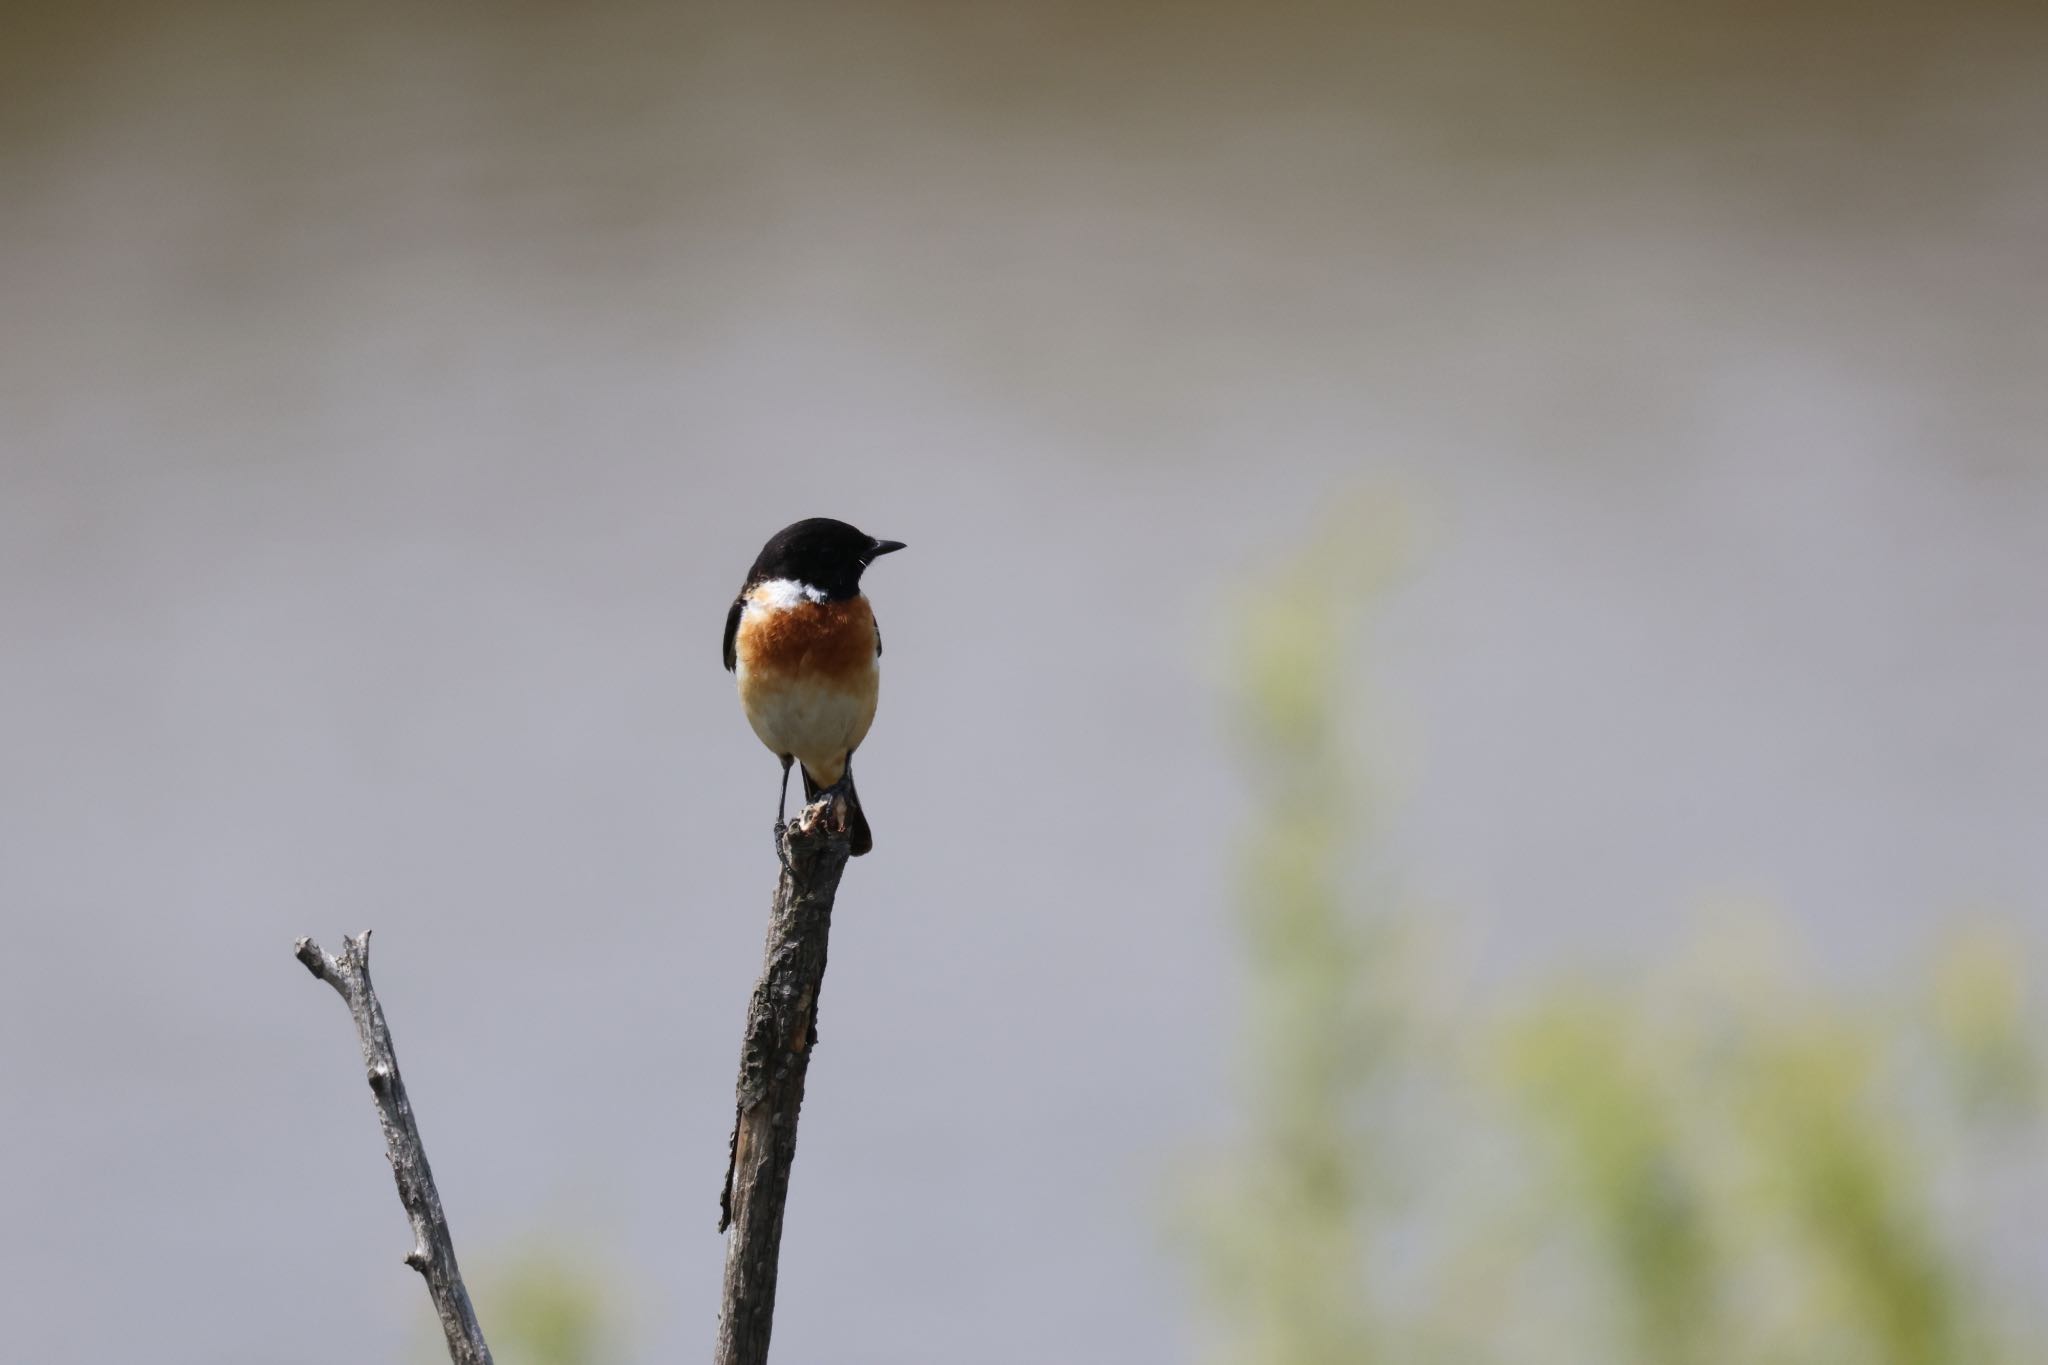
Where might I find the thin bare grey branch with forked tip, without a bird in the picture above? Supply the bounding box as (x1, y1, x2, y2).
(297, 929, 492, 1365)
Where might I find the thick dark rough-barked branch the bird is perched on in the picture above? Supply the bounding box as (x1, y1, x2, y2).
(715, 796, 850, 1365)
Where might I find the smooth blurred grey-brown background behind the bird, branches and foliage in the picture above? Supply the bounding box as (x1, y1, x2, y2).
(0, 0, 2048, 1365)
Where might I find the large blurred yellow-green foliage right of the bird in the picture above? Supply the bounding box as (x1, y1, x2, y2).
(1190, 508, 2048, 1365)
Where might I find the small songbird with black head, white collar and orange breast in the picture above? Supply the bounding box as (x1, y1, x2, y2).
(725, 516, 903, 857)
